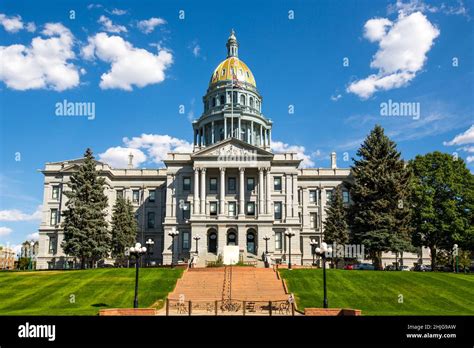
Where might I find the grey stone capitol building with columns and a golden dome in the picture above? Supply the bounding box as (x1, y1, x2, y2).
(37, 31, 429, 269)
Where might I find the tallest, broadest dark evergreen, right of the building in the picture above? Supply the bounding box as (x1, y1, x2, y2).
(349, 125, 411, 269)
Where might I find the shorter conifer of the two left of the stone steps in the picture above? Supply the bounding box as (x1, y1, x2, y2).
(112, 197, 138, 260)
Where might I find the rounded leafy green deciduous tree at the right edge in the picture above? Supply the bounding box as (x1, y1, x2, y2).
(409, 151, 474, 270)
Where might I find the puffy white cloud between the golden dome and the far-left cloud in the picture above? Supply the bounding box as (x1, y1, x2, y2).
(82, 33, 173, 91)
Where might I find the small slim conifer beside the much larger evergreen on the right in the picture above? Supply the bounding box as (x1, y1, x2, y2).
(324, 186, 349, 265)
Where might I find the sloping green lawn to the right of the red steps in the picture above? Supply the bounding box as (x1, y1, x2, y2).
(280, 269, 474, 315)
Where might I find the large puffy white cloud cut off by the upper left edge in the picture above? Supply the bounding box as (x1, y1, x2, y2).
(0, 23, 79, 91)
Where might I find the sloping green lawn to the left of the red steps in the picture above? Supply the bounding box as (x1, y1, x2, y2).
(0, 268, 183, 315)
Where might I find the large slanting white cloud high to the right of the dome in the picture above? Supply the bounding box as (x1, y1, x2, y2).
(347, 12, 439, 99)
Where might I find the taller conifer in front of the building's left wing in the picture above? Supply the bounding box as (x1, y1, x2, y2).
(62, 149, 110, 269)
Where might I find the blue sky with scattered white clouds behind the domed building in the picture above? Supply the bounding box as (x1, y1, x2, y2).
(0, 0, 474, 250)
